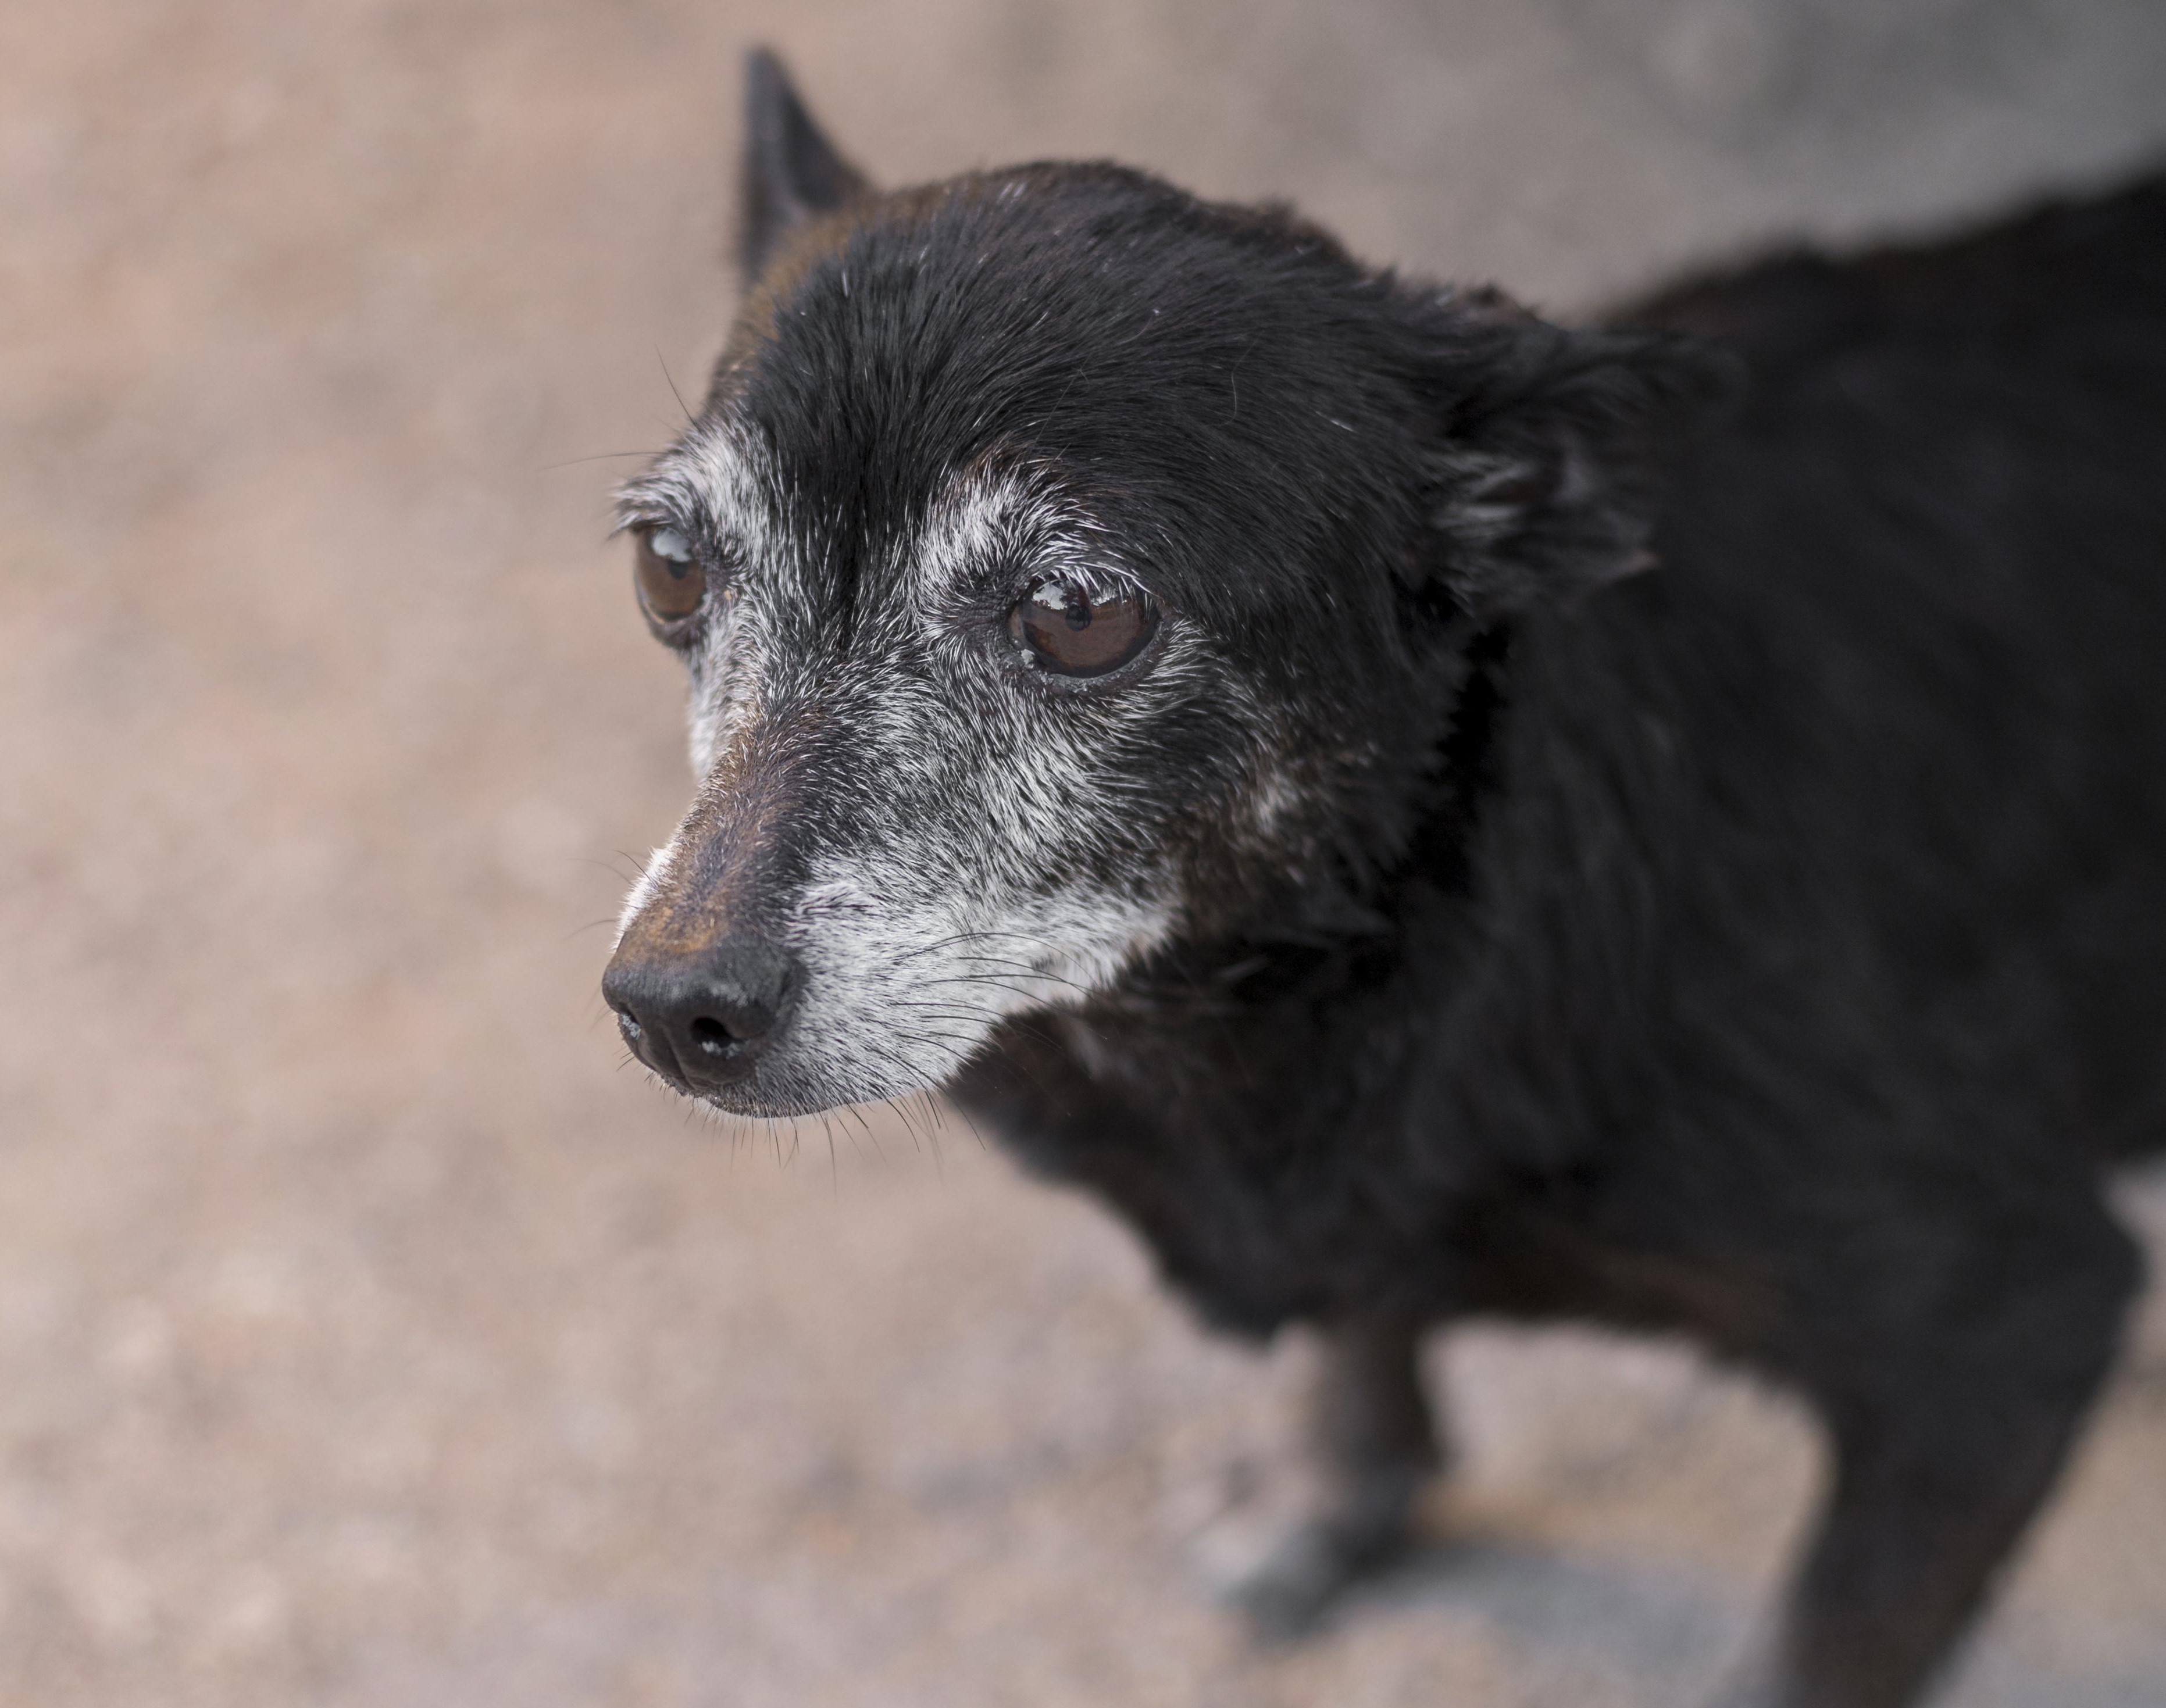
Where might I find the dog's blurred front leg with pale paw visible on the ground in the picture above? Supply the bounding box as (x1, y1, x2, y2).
(1207, 1316, 1445, 1636)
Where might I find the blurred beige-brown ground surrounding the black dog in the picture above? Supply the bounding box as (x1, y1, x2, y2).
(0, 0, 2166, 1708)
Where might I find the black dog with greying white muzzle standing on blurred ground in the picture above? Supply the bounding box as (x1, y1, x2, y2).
(602, 52, 2166, 1708)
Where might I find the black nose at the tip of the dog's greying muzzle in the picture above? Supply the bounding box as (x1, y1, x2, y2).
(602, 942, 800, 1091)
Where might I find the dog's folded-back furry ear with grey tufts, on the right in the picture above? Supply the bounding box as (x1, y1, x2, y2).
(1428, 296, 1739, 615)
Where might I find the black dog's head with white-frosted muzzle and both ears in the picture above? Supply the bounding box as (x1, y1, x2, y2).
(604, 54, 1703, 1115)
